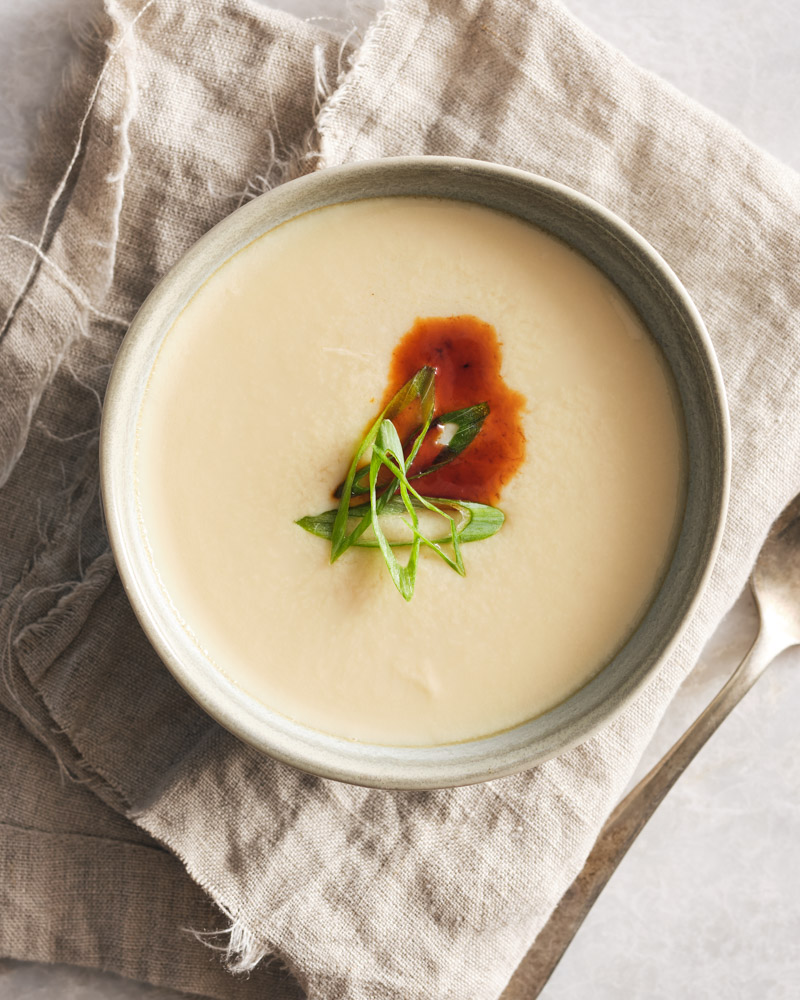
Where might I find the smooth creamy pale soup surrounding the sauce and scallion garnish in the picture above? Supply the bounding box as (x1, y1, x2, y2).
(137, 198, 684, 745)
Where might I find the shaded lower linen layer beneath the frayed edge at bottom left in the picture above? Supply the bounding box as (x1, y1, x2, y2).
(0, 709, 303, 1000)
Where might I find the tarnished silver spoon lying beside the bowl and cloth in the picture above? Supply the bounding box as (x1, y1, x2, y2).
(500, 496, 800, 1000)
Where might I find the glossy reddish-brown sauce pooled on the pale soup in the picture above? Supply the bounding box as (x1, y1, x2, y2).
(381, 316, 525, 504)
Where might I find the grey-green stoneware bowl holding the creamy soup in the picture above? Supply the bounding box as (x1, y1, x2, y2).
(100, 157, 730, 788)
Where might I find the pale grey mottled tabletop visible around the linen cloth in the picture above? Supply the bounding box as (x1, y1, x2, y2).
(0, 0, 800, 1000)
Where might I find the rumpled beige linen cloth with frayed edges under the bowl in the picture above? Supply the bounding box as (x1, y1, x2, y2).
(0, 0, 800, 1000)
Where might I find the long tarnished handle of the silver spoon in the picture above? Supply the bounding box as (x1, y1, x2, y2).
(500, 612, 792, 1000)
